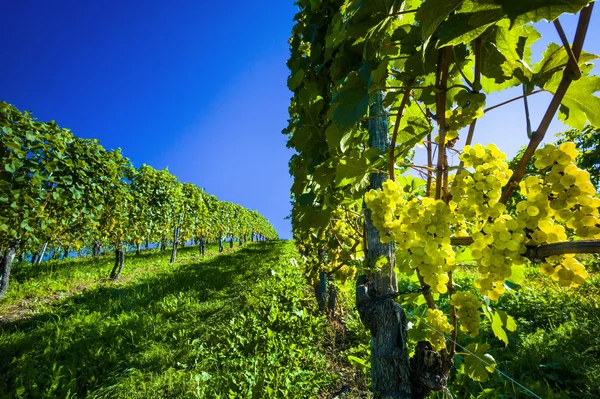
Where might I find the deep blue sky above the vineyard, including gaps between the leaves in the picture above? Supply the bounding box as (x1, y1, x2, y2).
(0, 0, 600, 238)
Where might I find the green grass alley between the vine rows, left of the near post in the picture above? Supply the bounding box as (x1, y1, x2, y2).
(0, 241, 333, 398)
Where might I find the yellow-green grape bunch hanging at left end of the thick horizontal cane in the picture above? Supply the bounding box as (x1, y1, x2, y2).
(470, 215, 527, 300)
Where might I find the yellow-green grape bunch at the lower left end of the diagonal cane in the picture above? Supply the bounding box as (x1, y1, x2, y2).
(450, 144, 512, 228)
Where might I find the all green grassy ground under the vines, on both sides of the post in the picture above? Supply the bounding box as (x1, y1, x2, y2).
(0, 241, 600, 399)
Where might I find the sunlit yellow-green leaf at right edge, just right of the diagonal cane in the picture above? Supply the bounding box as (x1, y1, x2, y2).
(544, 74, 600, 130)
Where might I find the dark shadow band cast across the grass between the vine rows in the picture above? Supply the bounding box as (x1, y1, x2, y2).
(0, 242, 281, 397)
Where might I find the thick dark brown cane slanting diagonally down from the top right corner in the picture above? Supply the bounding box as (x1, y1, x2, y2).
(499, 3, 594, 204)
